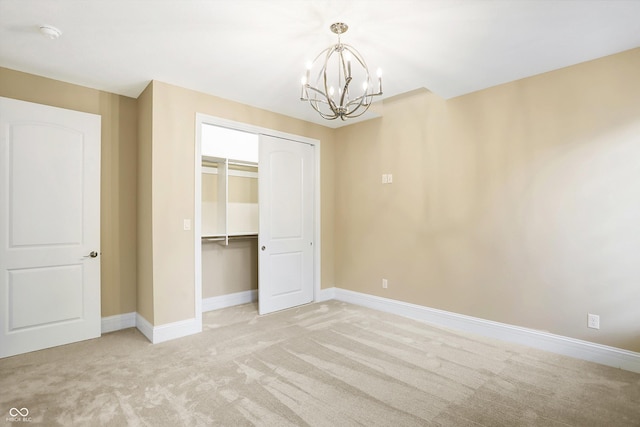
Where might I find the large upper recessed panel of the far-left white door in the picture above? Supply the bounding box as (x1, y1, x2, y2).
(8, 123, 83, 247)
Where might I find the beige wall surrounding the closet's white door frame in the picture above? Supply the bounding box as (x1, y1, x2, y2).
(148, 81, 334, 325)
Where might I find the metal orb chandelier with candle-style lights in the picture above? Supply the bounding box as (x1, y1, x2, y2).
(300, 22, 382, 120)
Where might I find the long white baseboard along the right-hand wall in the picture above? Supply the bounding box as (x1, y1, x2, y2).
(332, 288, 640, 373)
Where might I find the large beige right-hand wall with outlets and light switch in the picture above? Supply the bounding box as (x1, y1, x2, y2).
(335, 49, 640, 351)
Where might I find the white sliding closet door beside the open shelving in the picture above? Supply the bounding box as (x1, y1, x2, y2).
(258, 135, 314, 314)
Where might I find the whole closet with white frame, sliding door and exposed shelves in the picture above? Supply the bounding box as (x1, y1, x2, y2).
(194, 114, 320, 317)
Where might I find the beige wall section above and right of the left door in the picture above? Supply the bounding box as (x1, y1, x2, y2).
(0, 68, 137, 317)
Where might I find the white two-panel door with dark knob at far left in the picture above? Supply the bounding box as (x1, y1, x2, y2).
(0, 98, 100, 357)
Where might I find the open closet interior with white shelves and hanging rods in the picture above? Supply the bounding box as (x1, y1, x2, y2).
(201, 124, 259, 299)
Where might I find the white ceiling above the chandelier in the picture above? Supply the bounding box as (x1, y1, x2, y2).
(0, 0, 640, 127)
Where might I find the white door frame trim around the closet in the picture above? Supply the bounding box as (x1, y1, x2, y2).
(193, 113, 322, 324)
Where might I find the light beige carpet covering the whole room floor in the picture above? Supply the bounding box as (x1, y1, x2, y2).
(0, 301, 640, 427)
